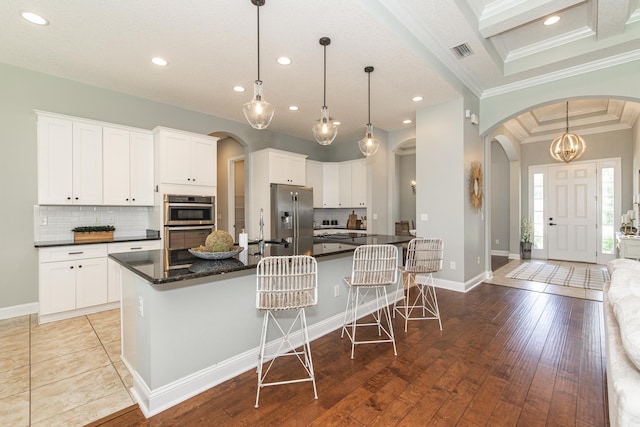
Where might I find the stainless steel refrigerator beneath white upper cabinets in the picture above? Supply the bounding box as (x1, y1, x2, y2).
(271, 184, 313, 242)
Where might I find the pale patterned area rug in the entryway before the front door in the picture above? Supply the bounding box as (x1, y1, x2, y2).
(505, 262, 609, 291)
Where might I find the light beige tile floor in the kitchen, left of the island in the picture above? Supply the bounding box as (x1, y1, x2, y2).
(0, 309, 134, 427)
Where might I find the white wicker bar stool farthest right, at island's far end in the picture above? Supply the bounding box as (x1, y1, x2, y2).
(393, 237, 444, 332)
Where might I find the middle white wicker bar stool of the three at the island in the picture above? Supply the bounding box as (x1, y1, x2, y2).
(340, 245, 398, 359)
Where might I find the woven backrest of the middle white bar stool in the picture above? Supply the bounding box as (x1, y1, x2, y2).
(351, 245, 398, 286)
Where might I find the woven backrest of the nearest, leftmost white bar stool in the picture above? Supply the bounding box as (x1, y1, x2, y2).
(256, 255, 318, 310)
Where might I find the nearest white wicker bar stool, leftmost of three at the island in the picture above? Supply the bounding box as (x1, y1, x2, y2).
(256, 255, 318, 408)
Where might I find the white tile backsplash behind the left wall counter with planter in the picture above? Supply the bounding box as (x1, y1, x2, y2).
(33, 205, 158, 242)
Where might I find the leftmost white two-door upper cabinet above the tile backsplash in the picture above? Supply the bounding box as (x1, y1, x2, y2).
(38, 113, 102, 205)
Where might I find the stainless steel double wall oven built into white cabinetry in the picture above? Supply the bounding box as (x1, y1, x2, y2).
(164, 194, 216, 270)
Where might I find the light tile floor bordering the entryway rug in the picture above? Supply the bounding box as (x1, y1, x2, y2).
(484, 259, 606, 301)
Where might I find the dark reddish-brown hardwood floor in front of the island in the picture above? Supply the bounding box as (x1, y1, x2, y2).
(94, 284, 608, 426)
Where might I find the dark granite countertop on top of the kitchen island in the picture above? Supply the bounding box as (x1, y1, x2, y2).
(109, 233, 412, 288)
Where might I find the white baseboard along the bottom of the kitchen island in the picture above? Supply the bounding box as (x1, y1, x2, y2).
(130, 290, 403, 418)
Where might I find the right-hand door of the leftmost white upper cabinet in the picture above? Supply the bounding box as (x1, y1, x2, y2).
(73, 122, 102, 205)
